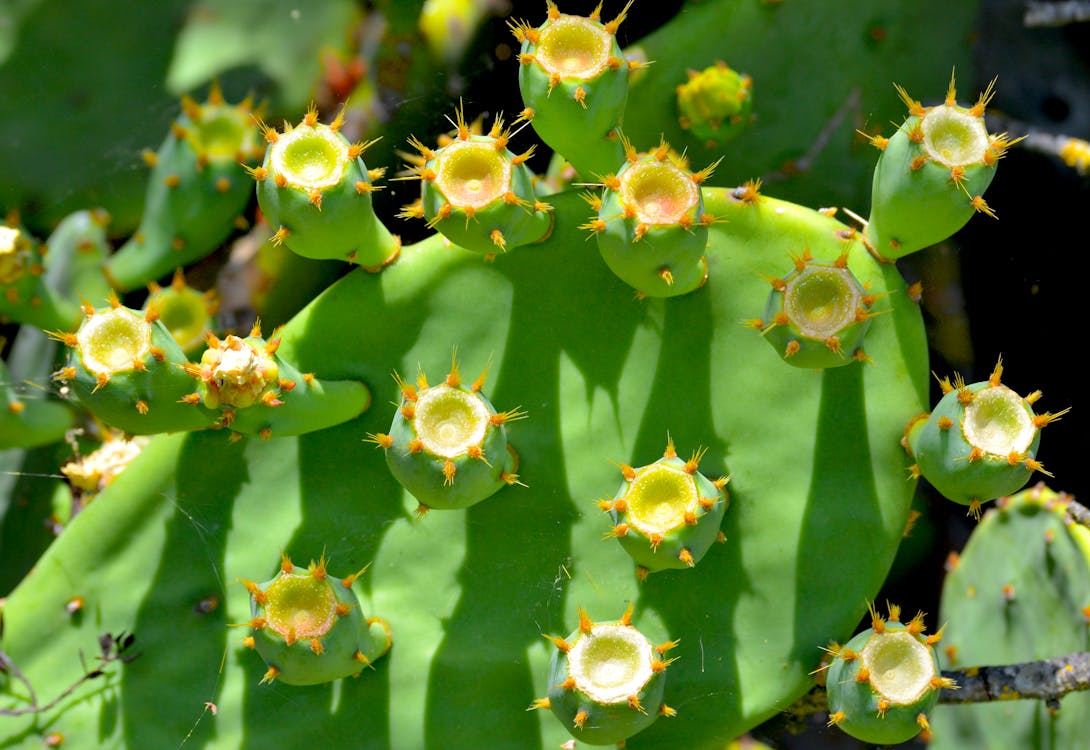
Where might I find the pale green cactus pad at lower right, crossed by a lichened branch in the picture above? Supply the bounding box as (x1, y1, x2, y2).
(931, 484, 1090, 750)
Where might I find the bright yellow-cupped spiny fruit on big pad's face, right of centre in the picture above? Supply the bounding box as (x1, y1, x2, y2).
(598, 440, 729, 578)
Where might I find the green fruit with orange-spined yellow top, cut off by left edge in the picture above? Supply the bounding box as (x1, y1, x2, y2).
(0, 226, 80, 330)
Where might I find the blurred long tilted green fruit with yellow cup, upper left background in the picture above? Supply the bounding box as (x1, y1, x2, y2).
(106, 85, 262, 291)
